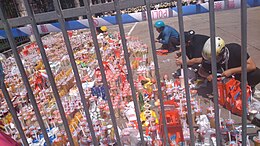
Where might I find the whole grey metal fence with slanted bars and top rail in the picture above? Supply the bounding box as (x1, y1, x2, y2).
(0, 0, 247, 146)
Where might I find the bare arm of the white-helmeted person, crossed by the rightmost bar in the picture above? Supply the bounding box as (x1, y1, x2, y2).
(222, 57, 256, 77)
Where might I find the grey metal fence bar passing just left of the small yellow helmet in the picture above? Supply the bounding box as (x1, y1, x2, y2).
(83, 0, 121, 146)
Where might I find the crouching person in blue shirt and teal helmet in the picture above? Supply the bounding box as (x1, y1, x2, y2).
(154, 21, 180, 52)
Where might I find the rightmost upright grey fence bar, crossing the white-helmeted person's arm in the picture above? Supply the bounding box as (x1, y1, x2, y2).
(241, 0, 247, 146)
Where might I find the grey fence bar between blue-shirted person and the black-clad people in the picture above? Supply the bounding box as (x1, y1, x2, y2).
(177, 0, 195, 146)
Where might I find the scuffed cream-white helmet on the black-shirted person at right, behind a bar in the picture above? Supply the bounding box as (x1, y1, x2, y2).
(202, 37, 228, 62)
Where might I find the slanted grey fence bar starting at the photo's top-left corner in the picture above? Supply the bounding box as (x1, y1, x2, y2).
(0, 3, 51, 145)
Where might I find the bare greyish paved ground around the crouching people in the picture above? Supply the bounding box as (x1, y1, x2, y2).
(108, 7, 260, 141)
